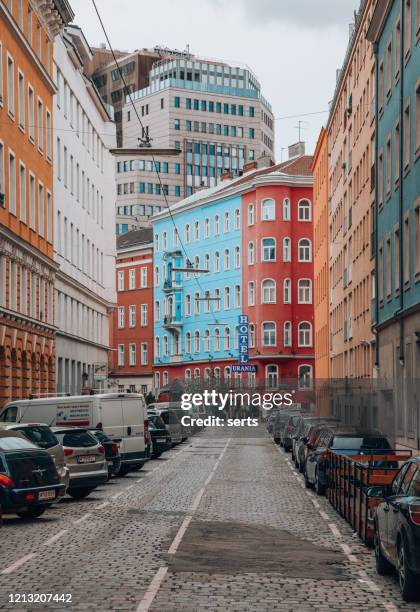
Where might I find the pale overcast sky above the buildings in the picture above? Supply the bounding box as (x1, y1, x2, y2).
(70, 0, 360, 161)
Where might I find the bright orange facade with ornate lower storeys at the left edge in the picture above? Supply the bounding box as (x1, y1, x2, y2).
(0, 0, 73, 405)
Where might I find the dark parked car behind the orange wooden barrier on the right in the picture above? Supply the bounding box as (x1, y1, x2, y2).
(305, 426, 393, 495)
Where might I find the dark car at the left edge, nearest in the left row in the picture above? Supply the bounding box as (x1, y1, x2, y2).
(0, 430, 65, 519)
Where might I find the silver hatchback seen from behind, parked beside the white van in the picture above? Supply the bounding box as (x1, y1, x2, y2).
(53, 427, 108, 499)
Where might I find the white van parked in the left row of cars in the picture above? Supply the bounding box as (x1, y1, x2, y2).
(0, 393, 149, 476)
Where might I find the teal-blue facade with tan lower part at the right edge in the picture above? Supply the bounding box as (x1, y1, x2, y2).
(367, 0, 420, 446)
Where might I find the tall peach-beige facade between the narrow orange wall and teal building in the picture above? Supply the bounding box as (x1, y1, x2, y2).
(326, 0, 375, 378)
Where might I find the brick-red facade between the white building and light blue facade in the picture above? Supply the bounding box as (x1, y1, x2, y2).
(110, 229, 153, 393)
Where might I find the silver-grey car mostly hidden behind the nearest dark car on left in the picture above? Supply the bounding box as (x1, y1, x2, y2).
(0, 423, 69, 490)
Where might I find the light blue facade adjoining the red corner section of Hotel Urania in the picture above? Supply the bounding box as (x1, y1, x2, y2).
(153, 186, 242, 388)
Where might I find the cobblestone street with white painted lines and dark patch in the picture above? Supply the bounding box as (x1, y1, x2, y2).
(0, 428, 416, 612)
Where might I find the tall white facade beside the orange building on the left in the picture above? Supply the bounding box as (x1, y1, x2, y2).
(53, 26, 116, 394)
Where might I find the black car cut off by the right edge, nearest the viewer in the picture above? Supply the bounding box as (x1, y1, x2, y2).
(375, 457, 420, 601)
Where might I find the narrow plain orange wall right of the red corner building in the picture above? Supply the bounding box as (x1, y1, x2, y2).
(312, 128, 330, 380)
